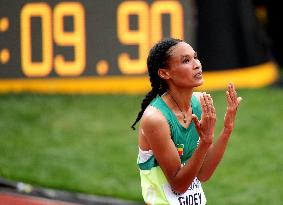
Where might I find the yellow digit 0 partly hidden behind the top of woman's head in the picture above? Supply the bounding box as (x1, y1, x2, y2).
(151, 1, 184, 44)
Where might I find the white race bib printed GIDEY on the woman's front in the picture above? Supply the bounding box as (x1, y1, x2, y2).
(164, 178, 206, 205)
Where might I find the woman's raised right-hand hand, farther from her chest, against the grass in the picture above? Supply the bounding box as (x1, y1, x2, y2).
(224, 83, 242, 132)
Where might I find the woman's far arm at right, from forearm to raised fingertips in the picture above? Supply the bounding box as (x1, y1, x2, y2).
(198, 83, 242, 181)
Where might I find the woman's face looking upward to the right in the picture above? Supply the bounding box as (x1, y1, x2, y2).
(165, 42, 203, 88)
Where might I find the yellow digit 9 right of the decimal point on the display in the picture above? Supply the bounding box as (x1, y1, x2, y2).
(117, 1, 149, 74)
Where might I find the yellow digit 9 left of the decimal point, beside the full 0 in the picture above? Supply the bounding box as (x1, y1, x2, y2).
(54, 2, 86, 76)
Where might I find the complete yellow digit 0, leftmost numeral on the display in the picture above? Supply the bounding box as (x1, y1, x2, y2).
(20, 3, 53, 77)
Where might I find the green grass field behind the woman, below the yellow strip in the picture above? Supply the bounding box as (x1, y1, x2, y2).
(0, 88, 283, 205)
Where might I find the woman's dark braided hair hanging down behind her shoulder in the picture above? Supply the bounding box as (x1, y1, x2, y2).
(131, 38, 182, 130)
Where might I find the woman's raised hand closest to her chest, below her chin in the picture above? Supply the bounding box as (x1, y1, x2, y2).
(192, 93, 216, 144)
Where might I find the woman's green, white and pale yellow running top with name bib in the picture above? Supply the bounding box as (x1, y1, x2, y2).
(138, 95, 206, 205)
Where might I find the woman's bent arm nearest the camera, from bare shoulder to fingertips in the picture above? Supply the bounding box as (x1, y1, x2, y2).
(140, 94, 215, 193)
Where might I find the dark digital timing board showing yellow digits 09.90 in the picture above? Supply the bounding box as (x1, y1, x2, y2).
(0, 0, 193, 78)
